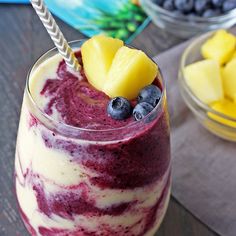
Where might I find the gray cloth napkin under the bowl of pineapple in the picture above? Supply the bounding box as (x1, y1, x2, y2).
(154, 28, 236, 236)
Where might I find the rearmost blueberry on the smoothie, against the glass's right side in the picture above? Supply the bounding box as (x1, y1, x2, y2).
(138, 84, 161, 107)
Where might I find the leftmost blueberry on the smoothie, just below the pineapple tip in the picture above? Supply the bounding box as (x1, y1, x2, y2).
(107, 97, 132, 120)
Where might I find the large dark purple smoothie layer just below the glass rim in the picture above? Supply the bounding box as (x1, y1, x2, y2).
(39, 108, 170, 189)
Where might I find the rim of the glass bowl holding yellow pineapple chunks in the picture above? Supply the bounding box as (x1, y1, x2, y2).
(178, 30, 236, 123)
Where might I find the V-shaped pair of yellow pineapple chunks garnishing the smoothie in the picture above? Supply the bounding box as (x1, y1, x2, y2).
(81, 35, 158, 99)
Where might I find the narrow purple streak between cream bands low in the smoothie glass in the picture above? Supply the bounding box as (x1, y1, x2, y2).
(33, 184, 135, 219)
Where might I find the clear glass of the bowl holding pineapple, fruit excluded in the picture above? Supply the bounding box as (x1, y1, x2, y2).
(178, 32, 236, 142)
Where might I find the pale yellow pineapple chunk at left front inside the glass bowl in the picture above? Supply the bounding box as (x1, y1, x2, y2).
(184, 60, 223, 104)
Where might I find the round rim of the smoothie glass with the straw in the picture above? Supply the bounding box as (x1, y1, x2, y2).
(25, 39, 166, 133)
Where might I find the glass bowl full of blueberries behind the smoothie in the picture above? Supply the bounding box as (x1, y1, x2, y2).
(140, 0, 236, 38)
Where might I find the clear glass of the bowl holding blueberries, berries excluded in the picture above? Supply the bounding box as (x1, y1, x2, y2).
(140, 0, 236, 38)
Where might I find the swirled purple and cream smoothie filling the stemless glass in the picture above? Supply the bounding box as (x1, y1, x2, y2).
(15, 36, 170, 236)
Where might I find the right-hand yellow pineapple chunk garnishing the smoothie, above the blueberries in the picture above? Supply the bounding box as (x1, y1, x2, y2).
(103, 46, 158, 100)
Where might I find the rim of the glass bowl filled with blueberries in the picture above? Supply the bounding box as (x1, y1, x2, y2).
(141, 0, 236, 23)
